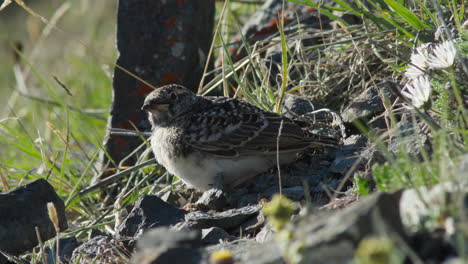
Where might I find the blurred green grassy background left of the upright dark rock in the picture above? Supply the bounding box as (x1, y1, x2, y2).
(0, 0, 117, 173)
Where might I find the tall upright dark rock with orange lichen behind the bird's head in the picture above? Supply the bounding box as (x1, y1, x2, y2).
(99, 0, 215, 176)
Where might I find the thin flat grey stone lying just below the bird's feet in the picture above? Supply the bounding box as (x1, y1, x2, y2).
(176, 205, 262, 231)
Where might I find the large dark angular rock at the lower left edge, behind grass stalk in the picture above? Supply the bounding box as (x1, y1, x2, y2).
(0, 179, 68, 258)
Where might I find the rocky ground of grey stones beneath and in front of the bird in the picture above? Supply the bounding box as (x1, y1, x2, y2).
(0, 91, 468, 263)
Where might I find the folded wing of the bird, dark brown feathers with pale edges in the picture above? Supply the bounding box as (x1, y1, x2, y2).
(176, 98, 332, 157)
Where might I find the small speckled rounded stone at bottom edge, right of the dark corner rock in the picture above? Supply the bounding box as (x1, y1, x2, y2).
(70, 236, 129, 264)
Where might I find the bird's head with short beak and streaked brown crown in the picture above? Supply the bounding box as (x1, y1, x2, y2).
(141, 84, 197, 126)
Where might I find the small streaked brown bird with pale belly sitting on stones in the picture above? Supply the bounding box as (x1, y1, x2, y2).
(141, 85, 336, 190)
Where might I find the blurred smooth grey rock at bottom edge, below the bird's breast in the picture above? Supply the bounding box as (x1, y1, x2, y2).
(132, 227, 202, 264)
